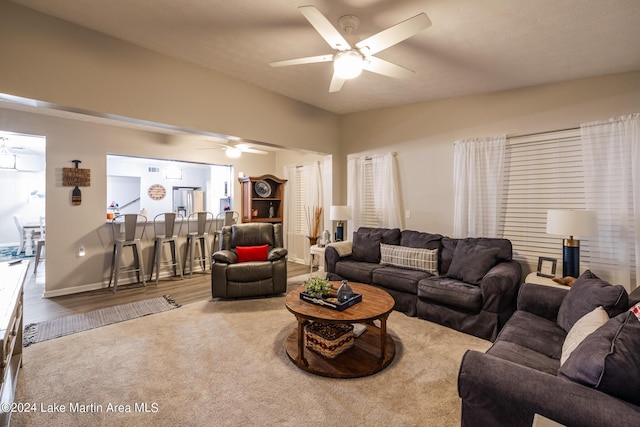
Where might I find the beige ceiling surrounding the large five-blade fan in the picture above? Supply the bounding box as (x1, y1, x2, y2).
(8, 0, 640, 113)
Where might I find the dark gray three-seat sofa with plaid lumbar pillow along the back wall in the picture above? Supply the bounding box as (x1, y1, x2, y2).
(325, 227, 522, 341)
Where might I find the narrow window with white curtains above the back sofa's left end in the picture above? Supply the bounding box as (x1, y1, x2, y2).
(345, 153, 404, 234)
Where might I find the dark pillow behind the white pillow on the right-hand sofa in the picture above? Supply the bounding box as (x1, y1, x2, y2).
(558, 270, 629, 332)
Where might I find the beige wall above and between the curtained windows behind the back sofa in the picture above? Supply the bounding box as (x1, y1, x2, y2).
(340, 72, 640, 235)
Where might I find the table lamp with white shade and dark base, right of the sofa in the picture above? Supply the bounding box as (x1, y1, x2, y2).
(547, 209, 598, 277)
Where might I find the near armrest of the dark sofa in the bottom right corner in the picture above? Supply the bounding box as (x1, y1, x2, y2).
(458, 351, 640, 426)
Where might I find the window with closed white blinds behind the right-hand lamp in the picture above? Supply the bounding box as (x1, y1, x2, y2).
(501, 129, 589, 271)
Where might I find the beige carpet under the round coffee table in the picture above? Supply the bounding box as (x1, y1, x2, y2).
(11, 286, 490, 427)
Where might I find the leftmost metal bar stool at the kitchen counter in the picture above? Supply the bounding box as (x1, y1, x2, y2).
(109, 214, 147, 293)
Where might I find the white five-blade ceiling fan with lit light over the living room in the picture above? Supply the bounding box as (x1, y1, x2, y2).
(269, 6, 431, 92)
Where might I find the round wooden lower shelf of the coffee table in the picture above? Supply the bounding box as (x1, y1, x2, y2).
(286, 326, 396, 378)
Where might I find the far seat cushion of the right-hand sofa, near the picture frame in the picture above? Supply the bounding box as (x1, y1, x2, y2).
(496, 310, 567, 362)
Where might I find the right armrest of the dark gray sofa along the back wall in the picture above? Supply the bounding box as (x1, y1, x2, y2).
(480, 260, 522, 313)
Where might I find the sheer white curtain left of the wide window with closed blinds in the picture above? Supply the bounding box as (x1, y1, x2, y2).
(453, 135, 507, 237)
